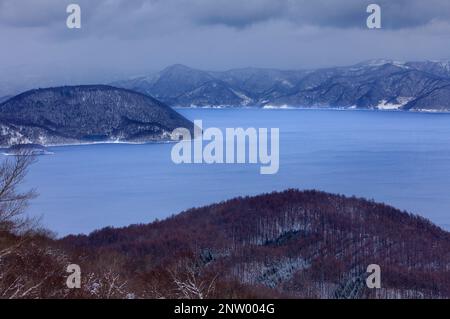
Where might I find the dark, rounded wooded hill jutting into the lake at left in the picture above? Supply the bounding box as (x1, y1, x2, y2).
(0, 85, 193, 146)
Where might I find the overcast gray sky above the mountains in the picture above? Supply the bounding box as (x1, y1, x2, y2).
(0, 0, 450, 93)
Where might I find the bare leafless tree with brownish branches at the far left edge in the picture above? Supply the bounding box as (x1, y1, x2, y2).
(0, 152, 65, 299)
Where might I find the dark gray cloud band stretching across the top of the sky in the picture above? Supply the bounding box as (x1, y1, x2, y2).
(0, 0, 450, 30)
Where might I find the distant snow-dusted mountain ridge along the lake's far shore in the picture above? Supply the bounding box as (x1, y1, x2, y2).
(113, 60, 450, 111)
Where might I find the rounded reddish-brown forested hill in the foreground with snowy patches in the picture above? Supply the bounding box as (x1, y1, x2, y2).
(61, 190, 450, 298)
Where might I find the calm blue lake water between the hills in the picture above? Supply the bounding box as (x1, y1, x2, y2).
(7, 109, 450, 235)
